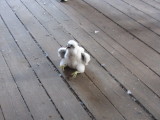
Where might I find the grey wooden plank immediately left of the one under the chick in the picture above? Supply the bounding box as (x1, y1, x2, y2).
(2, 0, 90, 120)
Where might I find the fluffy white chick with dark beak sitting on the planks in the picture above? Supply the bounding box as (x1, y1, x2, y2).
(58, 40, 90, 78)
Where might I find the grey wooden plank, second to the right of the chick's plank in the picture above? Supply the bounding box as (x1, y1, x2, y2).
(21, 0, 159, 119)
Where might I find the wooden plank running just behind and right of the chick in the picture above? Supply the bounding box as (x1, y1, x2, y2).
(13, 1, 154, 120)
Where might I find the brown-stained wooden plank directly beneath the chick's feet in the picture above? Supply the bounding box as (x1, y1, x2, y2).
(5, 1, 129, 120)
